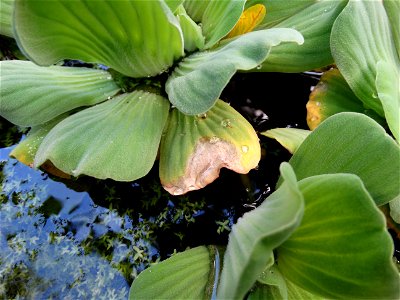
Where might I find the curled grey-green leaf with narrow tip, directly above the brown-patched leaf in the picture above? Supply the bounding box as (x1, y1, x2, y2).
(165, 29, 303, 115)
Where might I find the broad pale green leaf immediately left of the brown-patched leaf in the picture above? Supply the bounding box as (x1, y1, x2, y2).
(35, 91, 169, 181)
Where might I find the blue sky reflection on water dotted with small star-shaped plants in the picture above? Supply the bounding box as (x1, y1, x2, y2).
(0, 148, 157, 299)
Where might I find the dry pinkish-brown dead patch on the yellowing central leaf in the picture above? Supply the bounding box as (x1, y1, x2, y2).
(162, 136, 250, 195)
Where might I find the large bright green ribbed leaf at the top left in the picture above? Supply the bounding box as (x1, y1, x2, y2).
(14, 0, 183, 77)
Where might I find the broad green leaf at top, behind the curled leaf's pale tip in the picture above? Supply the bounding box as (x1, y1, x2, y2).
(255, 0, 346, 72)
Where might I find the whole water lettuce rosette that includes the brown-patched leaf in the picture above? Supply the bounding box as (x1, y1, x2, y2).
(0, 0, 303, 194)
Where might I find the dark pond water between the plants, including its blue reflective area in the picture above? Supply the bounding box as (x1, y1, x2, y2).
(0, 70, 317, 299)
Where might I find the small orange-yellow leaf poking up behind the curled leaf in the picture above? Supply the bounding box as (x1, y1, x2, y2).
(226, 4, 266, 38)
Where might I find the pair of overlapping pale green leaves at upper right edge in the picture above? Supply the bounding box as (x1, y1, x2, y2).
(331, 0, 400, 140)
